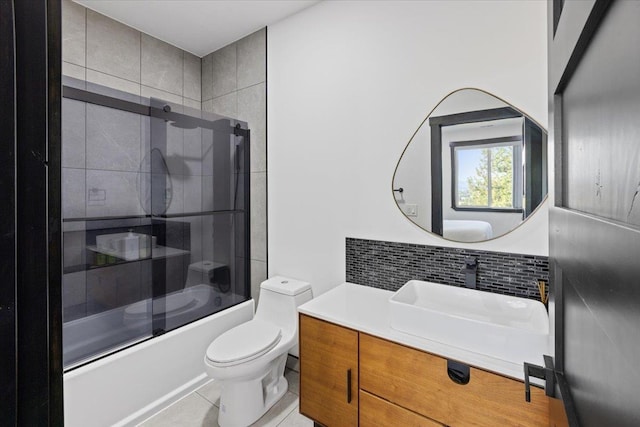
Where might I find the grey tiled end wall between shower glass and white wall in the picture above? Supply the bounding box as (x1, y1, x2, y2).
(202, 29, 267, 300)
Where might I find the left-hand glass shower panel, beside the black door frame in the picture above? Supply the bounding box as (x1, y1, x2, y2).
(62, 79, 153, 369)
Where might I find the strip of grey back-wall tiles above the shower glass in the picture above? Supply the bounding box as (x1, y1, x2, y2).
(62, 0, 201, 109)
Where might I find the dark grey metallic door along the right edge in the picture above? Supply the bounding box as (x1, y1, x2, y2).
(549, 0, 640, 426)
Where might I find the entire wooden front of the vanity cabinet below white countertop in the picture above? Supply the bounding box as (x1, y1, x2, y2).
(300, 314, 550, 427)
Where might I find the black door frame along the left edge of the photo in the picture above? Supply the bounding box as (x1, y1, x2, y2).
(0, 0, 63, 426)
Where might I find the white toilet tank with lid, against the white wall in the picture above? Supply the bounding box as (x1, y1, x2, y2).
(255, 276, 312, 356)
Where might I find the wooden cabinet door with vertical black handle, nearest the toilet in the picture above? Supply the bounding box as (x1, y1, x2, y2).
(300, 314, 358, 427)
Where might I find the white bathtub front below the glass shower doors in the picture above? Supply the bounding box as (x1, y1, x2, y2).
(64, 300, 254, 427)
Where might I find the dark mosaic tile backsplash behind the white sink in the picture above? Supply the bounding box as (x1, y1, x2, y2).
(346, 238, 549, 300)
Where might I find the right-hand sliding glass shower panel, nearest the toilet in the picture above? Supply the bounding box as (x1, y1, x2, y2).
(150, 99, 249, 333)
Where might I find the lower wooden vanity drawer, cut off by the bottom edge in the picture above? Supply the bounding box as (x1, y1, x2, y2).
(360, 390, 443, 427)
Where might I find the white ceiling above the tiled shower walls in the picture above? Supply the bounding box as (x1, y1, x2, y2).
(74, 0, 319, 57)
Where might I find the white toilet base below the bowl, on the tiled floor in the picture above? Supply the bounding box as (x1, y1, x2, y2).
(218, 353, 289, 427)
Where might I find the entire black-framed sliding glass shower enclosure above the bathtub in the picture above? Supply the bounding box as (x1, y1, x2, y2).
(62, 79, 249, 369)
